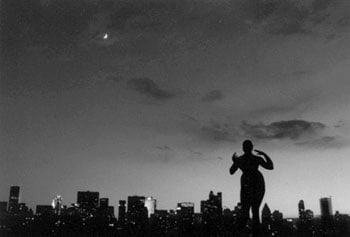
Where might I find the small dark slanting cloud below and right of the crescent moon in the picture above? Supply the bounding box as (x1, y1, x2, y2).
(127, 78, 175, 100)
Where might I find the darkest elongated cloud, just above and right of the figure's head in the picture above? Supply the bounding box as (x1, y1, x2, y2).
(240, 120, 326, 140)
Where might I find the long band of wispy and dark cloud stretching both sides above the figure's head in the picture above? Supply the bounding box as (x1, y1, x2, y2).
(197, 119, 342, 147)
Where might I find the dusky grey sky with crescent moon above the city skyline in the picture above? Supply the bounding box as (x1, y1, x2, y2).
(0, 0, 350, 216)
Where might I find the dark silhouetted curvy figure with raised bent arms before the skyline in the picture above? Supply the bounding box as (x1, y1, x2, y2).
(230, 140, 273, 236)
